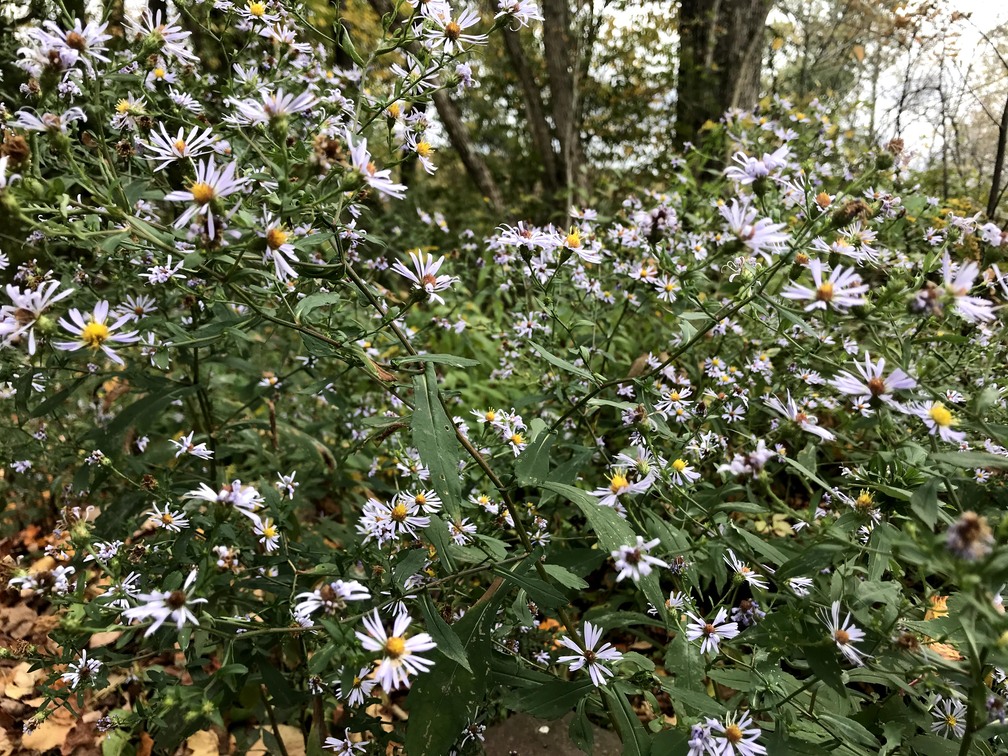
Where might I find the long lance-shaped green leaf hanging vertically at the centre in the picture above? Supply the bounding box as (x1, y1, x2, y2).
(411, 364, 462, 520)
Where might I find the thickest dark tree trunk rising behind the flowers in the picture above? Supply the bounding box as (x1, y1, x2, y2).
(675, 0, 773, 145)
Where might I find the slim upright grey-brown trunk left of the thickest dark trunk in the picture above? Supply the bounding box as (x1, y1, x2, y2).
(542, 0, 585, 199)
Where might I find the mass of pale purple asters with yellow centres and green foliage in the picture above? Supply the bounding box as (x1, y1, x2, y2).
(0, 0, 1008, 756)
